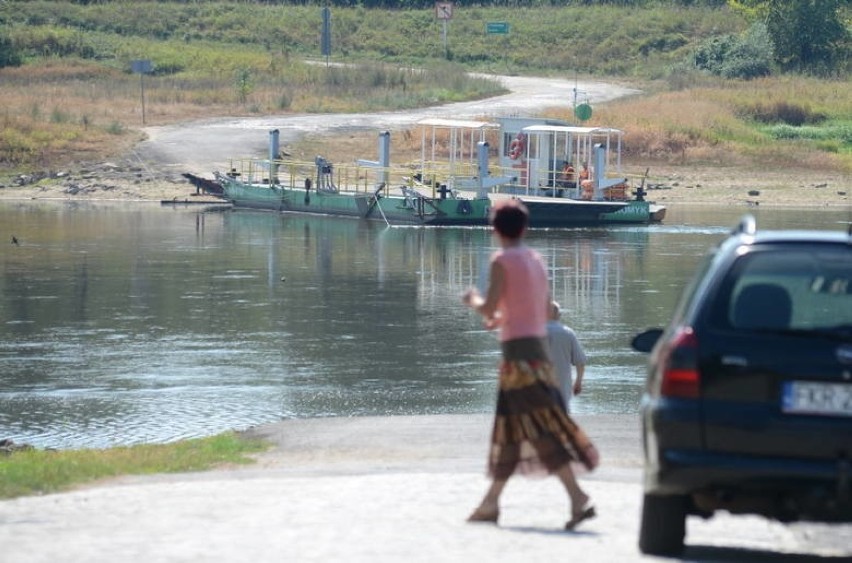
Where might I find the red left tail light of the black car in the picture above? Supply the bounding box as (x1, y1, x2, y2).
(659, 327, 701, 399)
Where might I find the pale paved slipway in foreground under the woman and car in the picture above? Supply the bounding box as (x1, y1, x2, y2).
(0, 415, 852, 563)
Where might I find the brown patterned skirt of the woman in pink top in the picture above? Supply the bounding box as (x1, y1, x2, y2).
(488, 338, 600, 480)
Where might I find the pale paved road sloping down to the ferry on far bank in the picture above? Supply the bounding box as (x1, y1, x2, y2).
(136, 76, 639, 177)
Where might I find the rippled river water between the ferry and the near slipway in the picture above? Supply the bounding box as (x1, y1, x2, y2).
(0, 201, 850, 448)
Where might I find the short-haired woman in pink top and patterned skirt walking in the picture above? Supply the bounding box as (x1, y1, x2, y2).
(462, 199, 599, 530)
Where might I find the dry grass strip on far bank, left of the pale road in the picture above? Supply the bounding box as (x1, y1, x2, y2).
(0, 56, 499, 171)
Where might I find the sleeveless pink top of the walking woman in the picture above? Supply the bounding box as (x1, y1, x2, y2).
(491, 245, 549, 342)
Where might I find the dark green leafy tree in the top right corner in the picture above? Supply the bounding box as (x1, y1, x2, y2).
(728, 0, 852, 74)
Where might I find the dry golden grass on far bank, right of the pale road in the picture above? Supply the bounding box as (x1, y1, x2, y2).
(553, 77, 852, 174)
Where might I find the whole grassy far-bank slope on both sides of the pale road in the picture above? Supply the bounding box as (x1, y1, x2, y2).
(0, 1, 852, 178)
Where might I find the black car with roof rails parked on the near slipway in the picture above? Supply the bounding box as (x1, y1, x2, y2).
(632, 216, 852, 555)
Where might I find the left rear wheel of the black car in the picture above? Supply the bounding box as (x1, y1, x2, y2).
(639, 494, 686, 555)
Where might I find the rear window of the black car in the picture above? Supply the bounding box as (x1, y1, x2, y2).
(716, 245, 852, 330)
